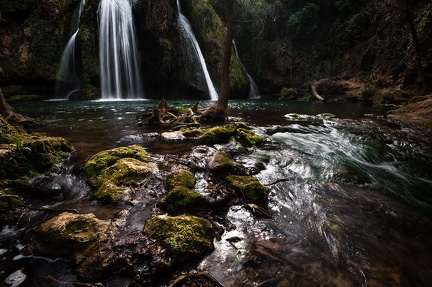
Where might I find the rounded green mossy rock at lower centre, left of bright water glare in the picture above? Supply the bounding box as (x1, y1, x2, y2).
(143, 215, 214, 263)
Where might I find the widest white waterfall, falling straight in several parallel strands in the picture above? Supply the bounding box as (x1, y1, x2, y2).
(98, 0, 144, 99)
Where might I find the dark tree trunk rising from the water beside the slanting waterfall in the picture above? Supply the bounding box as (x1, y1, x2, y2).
(202, 0, 234, 121)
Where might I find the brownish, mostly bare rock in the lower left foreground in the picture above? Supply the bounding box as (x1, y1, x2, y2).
(29, 212, 109, 274)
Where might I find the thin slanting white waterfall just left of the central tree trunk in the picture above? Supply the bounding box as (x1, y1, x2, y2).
(177, 0, 218, 100)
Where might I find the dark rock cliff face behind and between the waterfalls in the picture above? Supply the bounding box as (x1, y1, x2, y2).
(0, 0, 248, 98)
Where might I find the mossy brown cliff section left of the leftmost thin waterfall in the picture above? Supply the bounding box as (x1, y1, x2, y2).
(0, 0, 79, 88)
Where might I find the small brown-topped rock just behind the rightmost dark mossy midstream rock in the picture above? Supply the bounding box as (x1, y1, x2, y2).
(207, 151, 245, 178)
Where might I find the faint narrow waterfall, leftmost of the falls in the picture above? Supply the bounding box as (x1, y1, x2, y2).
(54, 0, 85, 99)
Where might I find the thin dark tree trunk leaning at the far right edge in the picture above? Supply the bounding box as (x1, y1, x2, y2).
(404, 0, 431, 95)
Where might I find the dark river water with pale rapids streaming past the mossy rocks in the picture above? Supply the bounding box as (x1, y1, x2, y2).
(0, 100, 432, 287)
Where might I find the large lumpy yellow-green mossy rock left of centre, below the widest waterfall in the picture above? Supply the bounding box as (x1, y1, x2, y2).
(84, 145, 158, 202)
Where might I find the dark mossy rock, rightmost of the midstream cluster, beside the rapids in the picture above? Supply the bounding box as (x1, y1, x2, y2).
(225, 175, 268, 206)
